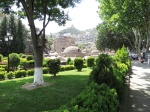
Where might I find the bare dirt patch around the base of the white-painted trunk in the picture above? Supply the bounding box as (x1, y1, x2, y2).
(21, 82, 51, 90)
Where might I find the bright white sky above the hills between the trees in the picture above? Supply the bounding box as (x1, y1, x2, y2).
(23, 0, 102, 34)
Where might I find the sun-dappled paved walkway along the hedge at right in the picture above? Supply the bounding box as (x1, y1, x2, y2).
(124, 61, 150, 112)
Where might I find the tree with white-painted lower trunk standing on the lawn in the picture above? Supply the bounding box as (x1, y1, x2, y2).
(0, 0, 80, 85)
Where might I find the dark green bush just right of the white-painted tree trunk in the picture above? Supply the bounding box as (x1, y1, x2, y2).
(47, 59, 60, 76)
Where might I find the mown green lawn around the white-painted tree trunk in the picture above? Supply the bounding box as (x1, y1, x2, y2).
(0, 68, 91, 112)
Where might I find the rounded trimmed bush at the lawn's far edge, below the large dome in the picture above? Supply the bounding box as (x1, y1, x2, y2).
(74, 57, 83, 71)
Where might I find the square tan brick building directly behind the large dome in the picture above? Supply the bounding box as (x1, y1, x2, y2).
(54, 36, 75, 54)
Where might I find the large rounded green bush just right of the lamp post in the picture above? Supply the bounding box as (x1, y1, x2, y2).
(9, 53, 20, 68)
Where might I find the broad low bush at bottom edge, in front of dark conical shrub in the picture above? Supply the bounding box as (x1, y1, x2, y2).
(69, 83, 119, 112)
